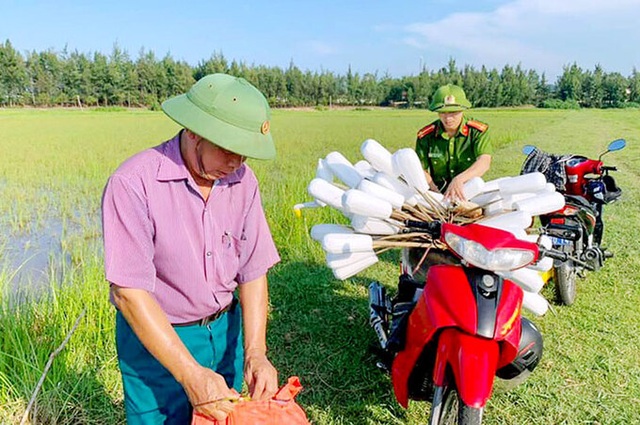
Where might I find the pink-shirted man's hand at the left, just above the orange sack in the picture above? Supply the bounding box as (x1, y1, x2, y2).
(182, 367, 240, 421)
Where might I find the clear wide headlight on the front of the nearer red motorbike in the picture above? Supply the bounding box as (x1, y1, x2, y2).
(444, 232, 536, 271)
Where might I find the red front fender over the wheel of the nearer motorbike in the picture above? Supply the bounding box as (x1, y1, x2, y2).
(433, 328, 500, 408)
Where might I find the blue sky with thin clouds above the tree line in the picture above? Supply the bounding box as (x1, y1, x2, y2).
(0, 0, 640, 81)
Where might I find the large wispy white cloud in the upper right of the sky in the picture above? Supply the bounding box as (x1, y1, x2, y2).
(403, 0, 640, 76)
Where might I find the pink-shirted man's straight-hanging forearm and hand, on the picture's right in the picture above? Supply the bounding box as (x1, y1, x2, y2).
(239, 275, 278, 400)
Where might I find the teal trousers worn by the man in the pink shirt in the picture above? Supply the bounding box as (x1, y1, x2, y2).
(116, 305, 244, 425)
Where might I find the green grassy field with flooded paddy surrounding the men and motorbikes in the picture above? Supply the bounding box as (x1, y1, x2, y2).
(0, 105, 640, 425)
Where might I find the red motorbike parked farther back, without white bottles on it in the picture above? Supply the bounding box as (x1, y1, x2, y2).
(522, 139, 626, 305)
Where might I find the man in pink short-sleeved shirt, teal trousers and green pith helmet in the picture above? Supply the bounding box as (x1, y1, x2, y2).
(102, 74, 280, 425)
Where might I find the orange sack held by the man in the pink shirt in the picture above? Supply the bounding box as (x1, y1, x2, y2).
(191, 376, 310, 425)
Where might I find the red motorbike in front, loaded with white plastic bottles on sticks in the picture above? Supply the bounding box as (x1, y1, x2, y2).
(369, 221, 563, 425)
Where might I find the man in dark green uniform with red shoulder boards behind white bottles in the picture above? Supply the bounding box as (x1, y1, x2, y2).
(416, 84, 492, 200)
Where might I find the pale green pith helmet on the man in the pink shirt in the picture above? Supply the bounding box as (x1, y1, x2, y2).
(162, 74, 276, 159)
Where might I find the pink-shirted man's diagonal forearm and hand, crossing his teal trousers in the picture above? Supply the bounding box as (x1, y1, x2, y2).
(111, 285, 238, 420)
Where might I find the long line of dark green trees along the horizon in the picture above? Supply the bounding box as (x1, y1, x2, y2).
(0, 40, 640, 110)
